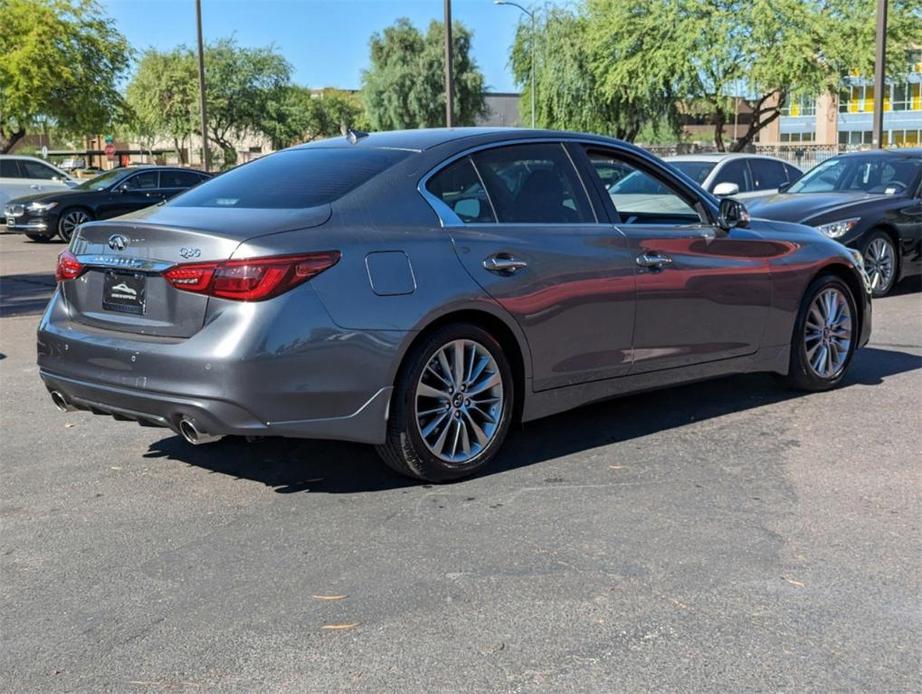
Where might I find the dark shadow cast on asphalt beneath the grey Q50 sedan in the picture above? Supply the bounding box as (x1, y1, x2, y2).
(145, 348, 922, 494)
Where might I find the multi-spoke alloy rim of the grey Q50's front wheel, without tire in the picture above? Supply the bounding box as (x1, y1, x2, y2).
(804, 287, 852, 379)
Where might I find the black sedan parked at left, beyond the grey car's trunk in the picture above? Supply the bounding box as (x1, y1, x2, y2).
(4, 166, 210, 241)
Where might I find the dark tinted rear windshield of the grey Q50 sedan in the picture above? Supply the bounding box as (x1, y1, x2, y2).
(169, 148, 410, 209)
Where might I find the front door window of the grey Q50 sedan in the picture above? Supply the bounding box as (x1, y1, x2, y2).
(588, 151, 700, 224)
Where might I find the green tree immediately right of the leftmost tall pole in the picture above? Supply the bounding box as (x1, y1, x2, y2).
(205, 39, 291, 166)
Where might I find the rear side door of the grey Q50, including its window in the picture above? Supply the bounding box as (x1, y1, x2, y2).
(425, 142, 634, 390)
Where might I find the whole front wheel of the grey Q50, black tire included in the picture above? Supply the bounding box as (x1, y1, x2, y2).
(788, 275, 858, 392)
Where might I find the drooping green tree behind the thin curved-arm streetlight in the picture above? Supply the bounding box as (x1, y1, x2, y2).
(511, 8, 675, 140)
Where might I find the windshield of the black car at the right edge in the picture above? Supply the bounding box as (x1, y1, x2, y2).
(788, 155, 922, 195)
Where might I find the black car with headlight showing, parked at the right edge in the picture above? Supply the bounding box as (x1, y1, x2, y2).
(749, 149, 922, 297)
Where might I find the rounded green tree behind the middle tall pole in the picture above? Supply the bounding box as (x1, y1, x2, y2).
(362, 19, 486, 130)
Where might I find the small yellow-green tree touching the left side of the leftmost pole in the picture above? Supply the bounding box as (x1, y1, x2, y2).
(125, 46, 198, 163)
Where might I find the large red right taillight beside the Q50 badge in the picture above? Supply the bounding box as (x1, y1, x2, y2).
(163, 251, 340, 301)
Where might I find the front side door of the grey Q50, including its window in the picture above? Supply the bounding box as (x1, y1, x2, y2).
(585, 146, 778, 373)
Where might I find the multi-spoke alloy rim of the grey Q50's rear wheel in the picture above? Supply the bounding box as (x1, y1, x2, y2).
(415, 340, 504, 465)
